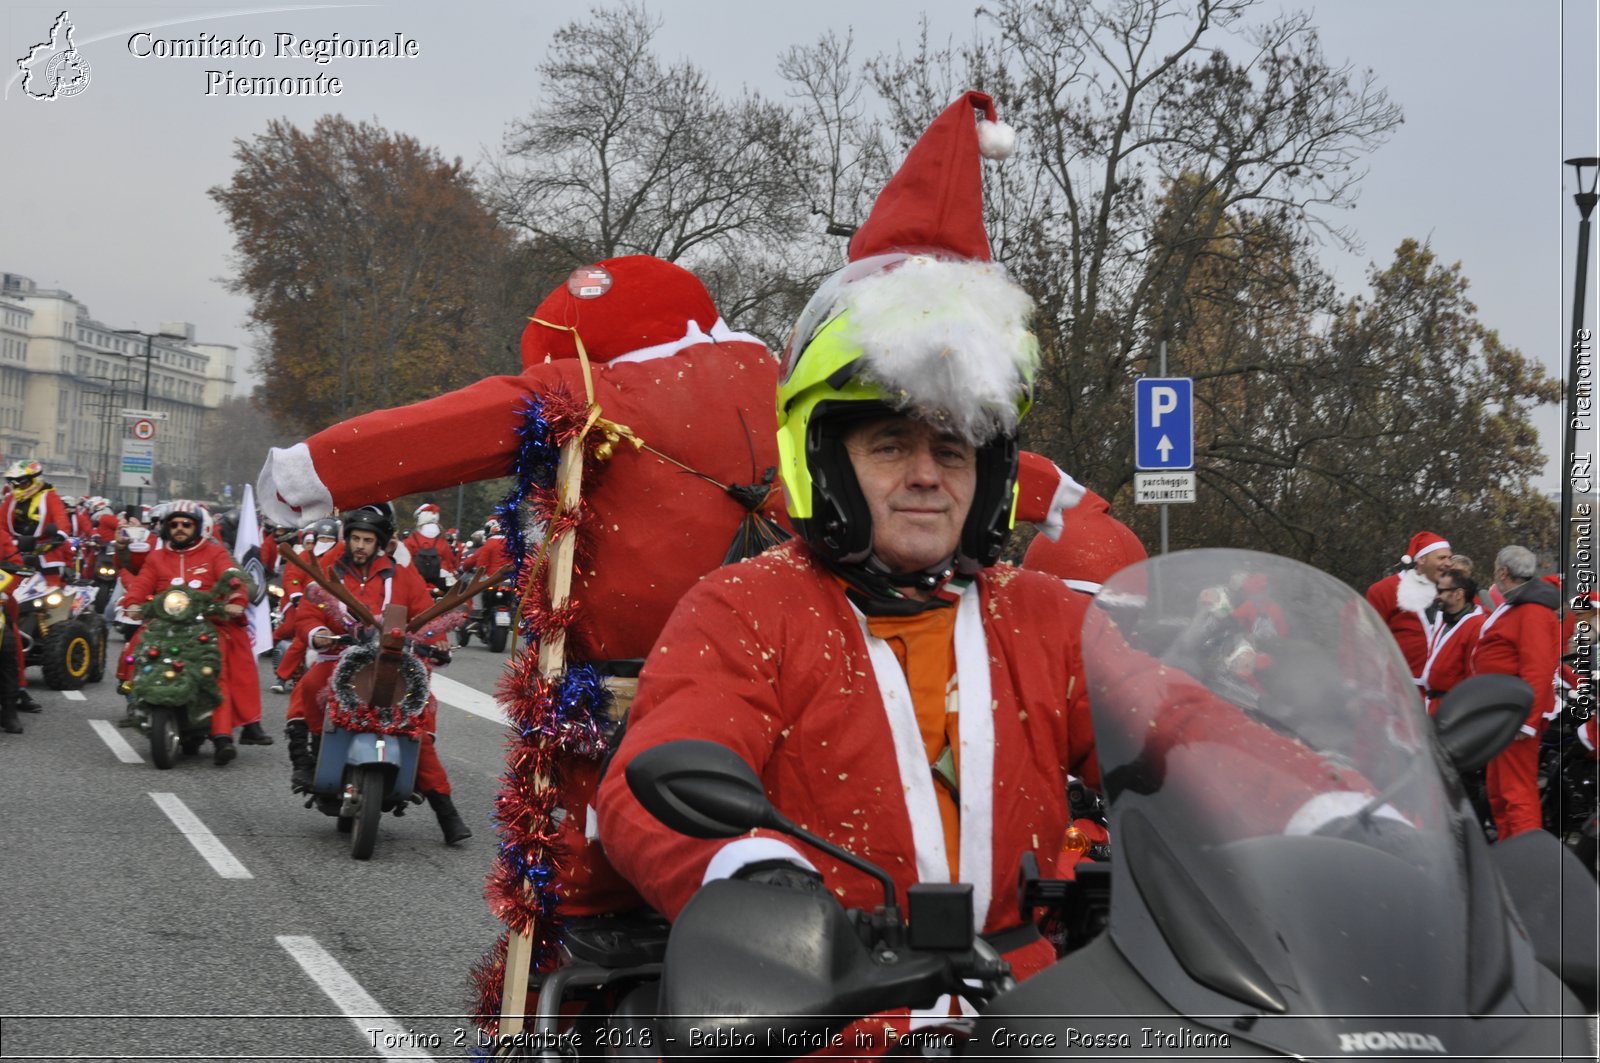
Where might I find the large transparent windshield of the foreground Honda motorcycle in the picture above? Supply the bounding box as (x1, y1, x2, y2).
(1083, 551, 1510, 1025)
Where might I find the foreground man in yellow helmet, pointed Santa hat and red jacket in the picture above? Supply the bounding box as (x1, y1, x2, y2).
(598, 93, 1382, 1047)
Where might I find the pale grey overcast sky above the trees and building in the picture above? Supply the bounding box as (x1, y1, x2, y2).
(0, 0, 1600, 488)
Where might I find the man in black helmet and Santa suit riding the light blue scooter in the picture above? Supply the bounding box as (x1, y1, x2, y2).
(285, 506, 472, 845)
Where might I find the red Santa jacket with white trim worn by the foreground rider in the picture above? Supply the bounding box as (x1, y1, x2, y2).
(598, 541, 1354, 973)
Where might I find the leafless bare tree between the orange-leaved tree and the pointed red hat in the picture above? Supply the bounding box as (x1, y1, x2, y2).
(490, 3, 812, 273)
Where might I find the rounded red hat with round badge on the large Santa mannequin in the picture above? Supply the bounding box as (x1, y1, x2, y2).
(522, 255, 760, 370)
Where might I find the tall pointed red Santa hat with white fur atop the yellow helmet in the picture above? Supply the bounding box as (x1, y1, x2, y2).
(784, 91, 1038, 443)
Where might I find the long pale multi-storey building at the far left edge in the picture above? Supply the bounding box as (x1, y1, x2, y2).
(0, 274, 238, 501)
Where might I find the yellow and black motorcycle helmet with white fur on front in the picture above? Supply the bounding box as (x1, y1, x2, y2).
(778, 253, 1038, 573)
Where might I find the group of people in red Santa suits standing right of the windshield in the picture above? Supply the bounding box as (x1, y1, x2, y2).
(1366, 532, 1595, 839)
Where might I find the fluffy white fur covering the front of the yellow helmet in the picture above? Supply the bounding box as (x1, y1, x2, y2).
(842, 255, 1038, 447)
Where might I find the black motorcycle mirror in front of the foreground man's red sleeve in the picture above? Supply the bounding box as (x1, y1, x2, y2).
(626, 738, 787, 837)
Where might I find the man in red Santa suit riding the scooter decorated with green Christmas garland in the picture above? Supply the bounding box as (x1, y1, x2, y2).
(123, 499, 272, 765)
